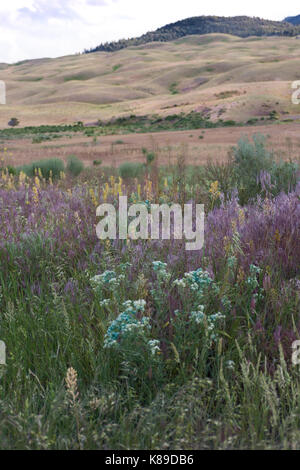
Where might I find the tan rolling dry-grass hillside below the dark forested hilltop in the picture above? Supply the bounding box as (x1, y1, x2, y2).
(0, 34, 300, 128)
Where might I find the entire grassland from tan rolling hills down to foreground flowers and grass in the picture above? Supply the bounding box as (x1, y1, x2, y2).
(0, 34, 300, 451)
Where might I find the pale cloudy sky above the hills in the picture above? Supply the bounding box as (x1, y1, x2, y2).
(0, 0, 300, 63)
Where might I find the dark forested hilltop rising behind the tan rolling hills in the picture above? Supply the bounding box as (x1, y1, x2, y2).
(85, 16, 300, 53)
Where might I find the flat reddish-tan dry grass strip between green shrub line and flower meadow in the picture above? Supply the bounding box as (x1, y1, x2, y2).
(5, 123, 300, 166)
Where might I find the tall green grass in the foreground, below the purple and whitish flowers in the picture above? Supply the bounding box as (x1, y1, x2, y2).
(0, 233, 300, 450)
